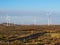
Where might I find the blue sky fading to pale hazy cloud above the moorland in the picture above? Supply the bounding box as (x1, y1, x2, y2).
(0, 0, 60, 24)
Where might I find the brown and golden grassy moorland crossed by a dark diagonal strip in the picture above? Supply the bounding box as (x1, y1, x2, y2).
(0, 24, 60, 45)
